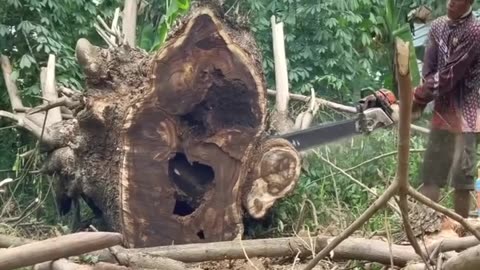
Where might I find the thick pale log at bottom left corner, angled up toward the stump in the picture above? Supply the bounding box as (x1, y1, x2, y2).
(0, 232, 122, 270)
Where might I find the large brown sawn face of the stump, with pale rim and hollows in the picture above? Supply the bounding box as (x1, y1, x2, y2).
(120, 5, 265, 246)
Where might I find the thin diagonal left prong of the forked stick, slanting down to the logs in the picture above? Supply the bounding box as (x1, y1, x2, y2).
(304, 181, 398, 270)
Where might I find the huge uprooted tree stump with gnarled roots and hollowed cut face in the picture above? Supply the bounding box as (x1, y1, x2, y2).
(36, 7, 300, 247)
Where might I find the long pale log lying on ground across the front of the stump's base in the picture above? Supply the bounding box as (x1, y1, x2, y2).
(120, 237, 420, 266)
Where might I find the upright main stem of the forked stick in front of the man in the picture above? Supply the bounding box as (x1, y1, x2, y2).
(395, 39, 430, 269)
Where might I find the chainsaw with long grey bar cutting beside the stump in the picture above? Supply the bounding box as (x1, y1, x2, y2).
(272, 89, 397, 151)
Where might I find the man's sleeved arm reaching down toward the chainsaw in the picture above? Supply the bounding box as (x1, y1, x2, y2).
(414, 27, 478, 104)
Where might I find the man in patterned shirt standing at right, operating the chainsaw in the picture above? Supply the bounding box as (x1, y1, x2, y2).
(413, 0, 480, 217)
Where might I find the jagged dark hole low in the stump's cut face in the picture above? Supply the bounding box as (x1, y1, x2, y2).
(168, 152, 215, 216)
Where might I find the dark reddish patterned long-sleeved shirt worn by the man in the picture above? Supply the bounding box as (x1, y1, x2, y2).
(413, 13, 480, 133)
